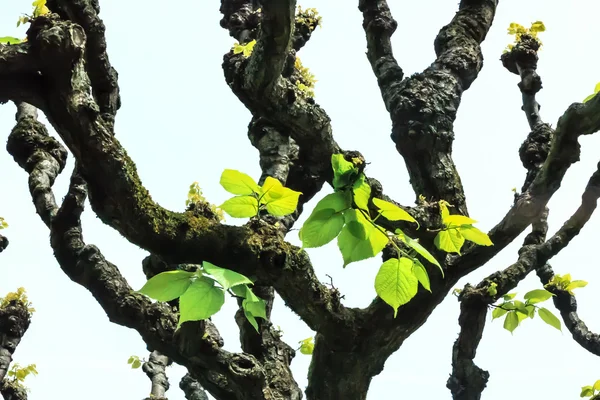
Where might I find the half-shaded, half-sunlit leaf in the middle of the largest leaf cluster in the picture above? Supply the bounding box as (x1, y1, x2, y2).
(338, 209, 389, 267)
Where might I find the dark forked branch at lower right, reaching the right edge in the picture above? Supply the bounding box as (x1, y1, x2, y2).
(448, 159, 600, 400)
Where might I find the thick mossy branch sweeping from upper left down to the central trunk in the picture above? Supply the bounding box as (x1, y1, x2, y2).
(1, 15, 352, 340)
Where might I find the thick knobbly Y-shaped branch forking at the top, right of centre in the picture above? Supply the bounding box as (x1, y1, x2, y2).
(359, 0, 497, 215)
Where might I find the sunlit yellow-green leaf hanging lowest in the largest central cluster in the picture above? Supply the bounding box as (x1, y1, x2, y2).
(375, 257, 419, 318)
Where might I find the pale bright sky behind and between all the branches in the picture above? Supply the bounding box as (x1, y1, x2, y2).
(0, 0, 600, 400)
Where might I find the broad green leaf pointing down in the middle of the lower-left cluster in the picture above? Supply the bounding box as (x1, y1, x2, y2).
(178, 277, 225, 327)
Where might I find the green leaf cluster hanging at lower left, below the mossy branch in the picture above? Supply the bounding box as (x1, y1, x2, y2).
(138, 261, 267, 331)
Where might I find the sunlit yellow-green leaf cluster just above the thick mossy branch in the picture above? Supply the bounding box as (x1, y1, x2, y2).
(219, 169, 302, 218)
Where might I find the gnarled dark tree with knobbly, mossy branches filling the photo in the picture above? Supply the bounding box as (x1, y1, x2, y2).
(0, 0, 600, 399)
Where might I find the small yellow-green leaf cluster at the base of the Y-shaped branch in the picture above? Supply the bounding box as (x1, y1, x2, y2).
(434, 200, 493, 254)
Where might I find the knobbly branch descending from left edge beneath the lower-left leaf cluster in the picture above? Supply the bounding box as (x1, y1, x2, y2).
(4, 101, 298, 400)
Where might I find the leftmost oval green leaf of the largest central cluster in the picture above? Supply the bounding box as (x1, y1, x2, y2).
(298, 209, 344, 248)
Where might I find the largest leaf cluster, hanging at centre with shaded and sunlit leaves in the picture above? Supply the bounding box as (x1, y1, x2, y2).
(299, 154, 443, 315)
